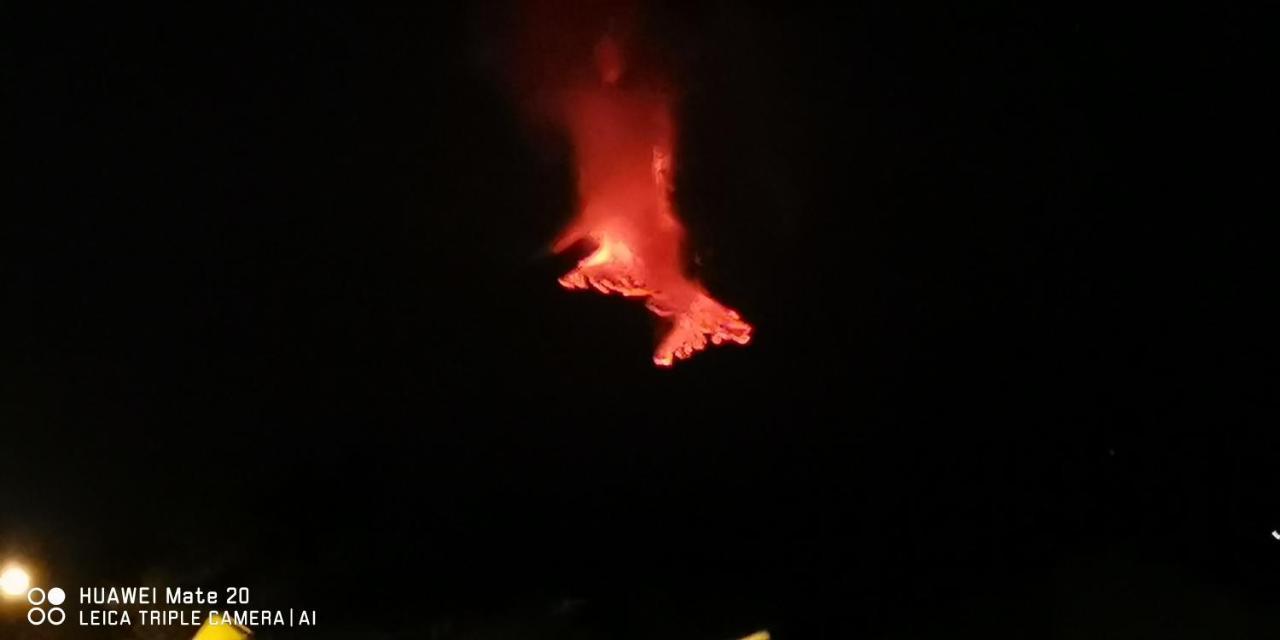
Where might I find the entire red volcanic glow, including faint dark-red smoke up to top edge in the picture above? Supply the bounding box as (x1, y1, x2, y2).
(504, 6, 753, 366)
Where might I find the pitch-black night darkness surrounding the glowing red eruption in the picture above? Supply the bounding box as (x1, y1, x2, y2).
(0, 3, 1280, 640)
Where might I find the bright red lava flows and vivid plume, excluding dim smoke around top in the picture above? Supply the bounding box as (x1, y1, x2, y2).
(554, 33, 751, 366)
